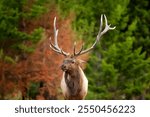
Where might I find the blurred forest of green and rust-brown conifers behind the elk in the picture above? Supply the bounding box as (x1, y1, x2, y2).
(0, 0, 150, 99)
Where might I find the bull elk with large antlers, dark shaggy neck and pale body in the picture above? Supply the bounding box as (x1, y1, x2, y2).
(50, 14, 115, 100)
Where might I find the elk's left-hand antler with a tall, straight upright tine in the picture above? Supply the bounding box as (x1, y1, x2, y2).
(50, 17, 69, 56)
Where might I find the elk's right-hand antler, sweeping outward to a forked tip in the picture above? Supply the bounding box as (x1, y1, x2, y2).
(74, 14, 116, 56)
